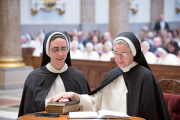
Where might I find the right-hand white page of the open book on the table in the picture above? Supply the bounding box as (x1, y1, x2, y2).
(98, 110, 130, 118)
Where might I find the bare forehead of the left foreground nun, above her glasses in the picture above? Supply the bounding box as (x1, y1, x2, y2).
(50, 38, 67, 47)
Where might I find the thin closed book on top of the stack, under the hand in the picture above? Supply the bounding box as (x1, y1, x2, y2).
(46, 100, 80, 106)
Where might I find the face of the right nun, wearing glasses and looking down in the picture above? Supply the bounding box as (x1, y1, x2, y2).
(114, 44, 134, 68)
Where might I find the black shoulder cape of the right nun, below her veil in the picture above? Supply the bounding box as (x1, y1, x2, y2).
(89, 65, 171, 120)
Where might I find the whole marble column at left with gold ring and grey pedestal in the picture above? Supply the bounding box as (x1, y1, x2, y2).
(0, 0, 33, 90)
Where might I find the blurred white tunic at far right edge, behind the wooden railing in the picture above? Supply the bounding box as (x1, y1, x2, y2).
(157, 53, 180, 65)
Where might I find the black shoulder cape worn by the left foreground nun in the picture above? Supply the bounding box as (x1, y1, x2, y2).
(18, 66, 90, 116)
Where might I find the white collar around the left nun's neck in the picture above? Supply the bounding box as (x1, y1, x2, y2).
(46, 63, 68, 73)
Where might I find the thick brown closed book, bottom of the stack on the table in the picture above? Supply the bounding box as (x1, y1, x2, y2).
(46, 104, 79, 115)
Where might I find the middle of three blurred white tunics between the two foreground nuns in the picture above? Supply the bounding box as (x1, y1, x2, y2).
(83, 51, 99, 60)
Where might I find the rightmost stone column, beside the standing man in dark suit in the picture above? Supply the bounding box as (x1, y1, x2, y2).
(151, 0, 164, 30)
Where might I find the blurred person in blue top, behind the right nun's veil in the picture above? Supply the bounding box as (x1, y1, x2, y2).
(151, 37, 163, 56)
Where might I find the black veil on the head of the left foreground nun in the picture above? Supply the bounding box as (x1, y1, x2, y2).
(41, 31, 71, 66)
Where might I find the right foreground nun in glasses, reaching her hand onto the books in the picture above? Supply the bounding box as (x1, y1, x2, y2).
(53, 32, 171, 120)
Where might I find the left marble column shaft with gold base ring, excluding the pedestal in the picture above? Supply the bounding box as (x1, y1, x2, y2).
(0, 0, 25, 68)
